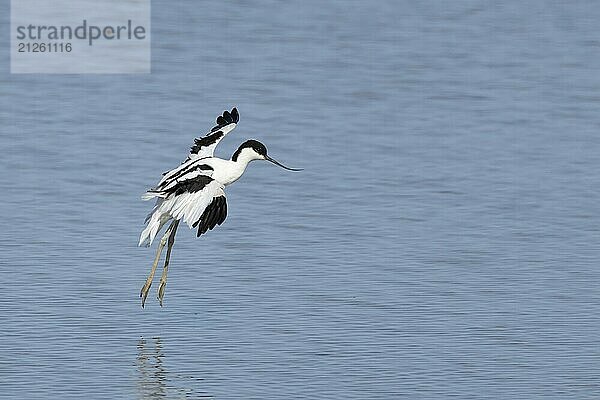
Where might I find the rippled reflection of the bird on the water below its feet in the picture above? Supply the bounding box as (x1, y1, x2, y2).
(136, 337, 212, 400)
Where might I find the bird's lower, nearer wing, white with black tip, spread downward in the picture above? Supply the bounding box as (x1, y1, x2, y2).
(140, 175, 227, 243)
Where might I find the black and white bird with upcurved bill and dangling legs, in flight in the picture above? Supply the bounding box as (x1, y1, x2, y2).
(139, 108, 301, 307)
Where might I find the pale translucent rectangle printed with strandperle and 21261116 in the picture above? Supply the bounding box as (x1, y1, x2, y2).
(10, 0, 150, 74)
